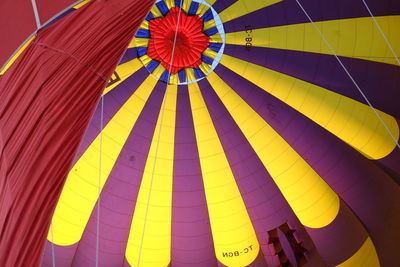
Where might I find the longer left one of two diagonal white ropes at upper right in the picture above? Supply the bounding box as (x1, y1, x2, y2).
(295, 0, 400, 151)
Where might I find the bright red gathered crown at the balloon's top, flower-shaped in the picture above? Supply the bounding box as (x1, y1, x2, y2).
(147, 7, 210, 74)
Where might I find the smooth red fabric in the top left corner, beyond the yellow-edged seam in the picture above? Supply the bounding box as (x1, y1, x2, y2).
(0, 0, 36, 68)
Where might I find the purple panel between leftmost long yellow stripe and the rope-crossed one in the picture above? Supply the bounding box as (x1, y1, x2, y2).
(68, 82, 165, 266)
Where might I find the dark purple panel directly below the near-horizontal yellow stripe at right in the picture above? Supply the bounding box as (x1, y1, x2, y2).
(225, 45, 400, 118)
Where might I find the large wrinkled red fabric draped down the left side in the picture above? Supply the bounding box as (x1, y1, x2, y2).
(0, 0, 153, 267)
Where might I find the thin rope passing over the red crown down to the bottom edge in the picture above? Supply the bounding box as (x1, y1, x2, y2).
(137, 0, 183, 267)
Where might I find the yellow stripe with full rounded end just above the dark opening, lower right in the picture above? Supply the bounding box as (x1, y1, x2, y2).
(207, 72, 340, 228)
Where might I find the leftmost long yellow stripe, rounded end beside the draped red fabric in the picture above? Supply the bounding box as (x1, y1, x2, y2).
(47, 76, 157, 246)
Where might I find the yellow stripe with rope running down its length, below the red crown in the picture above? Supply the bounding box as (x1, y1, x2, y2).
(126, 85, 177, 267)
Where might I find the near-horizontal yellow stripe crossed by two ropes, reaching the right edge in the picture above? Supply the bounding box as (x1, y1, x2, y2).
(226, 16, 400, 64)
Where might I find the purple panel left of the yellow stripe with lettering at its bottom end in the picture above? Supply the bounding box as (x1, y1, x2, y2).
(171, 86, 217, 267)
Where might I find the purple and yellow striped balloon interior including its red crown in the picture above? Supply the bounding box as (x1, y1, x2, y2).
(0, 0, 400, 267)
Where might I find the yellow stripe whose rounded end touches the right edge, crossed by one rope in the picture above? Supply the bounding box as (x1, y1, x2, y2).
(221, 55, 399, 159)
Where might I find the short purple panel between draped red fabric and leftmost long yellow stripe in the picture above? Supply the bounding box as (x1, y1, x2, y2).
(74, 68, 149, 163)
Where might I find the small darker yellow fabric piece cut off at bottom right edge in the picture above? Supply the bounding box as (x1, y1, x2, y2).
(337, 237, 380, 267)
